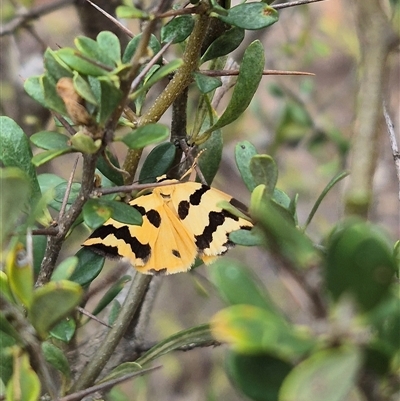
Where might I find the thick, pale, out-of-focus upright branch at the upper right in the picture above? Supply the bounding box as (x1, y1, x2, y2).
(345, 0, 396, 218)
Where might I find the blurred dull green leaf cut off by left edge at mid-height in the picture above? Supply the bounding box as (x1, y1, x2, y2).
(0, 167, 31, 246)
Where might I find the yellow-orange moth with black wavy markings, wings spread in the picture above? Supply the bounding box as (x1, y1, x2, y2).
(82, 178, 253, 274)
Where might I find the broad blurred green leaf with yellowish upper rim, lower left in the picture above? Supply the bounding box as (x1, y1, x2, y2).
(28, 280, 83, 338)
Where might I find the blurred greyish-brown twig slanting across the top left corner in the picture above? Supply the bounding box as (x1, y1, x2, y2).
(0, 0, 76, 36)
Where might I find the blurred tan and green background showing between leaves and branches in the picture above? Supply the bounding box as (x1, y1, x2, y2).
(0, 0, 400, 401)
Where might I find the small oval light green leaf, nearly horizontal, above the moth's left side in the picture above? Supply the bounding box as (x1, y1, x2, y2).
(121, 124, 169, 149)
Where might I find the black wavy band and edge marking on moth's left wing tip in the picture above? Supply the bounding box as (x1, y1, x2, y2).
(87, 224, 151, 262)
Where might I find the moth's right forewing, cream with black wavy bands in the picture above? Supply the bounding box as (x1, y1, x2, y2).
(172, 182, 253, 263)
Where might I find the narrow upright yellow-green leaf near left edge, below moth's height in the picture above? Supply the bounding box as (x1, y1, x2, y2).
(6, 243, 33, 309)
